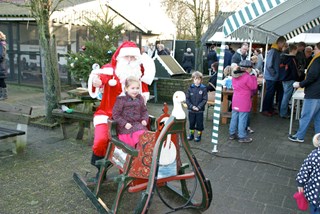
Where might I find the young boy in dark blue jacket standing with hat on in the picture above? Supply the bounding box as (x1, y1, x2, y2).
(186, 71, 208, 142)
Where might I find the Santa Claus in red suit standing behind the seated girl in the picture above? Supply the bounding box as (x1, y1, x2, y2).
(88, 41, 155, 177)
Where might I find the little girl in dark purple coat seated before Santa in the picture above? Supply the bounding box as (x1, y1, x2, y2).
(112, 77, 149, 148)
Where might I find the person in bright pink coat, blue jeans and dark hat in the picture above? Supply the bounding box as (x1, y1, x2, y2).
(229, 60, 258, 143)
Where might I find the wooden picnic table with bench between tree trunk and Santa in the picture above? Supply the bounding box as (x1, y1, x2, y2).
(52, 99, 93, 141)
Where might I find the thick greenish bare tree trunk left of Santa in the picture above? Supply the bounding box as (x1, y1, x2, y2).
(4, 0, 64, 123)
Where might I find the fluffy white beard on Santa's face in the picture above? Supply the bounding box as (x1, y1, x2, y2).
(115, 58, 142, 84)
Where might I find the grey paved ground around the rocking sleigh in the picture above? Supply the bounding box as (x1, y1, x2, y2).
(0, 86, 313, 214)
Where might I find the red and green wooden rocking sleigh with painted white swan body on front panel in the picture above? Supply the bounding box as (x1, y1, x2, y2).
(73, 91, 212, 213)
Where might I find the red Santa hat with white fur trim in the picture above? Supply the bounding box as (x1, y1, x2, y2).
(111, 41, 141, 67)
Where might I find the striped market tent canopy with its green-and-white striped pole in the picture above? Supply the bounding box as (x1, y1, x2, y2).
(211, 0, 320, 152)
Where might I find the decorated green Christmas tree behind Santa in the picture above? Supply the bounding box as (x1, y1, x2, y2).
(67, 14, 123, 81)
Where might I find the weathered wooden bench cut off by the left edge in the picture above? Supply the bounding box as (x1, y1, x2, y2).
(0, 102, 32, 153)
